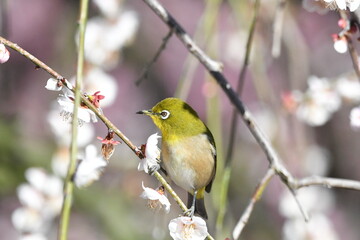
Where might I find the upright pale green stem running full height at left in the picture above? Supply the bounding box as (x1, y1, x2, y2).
(58, 0, 89, 240)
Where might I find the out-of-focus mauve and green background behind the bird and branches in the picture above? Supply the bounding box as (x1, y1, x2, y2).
(0, 0, 360, 240)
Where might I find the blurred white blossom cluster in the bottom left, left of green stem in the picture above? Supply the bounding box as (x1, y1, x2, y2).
(12, 168, 63, 240)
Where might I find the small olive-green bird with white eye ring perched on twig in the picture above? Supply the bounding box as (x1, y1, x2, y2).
(137, 98, 216, 220)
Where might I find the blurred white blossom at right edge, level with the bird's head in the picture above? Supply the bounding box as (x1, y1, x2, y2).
(336, 77, 360, 102)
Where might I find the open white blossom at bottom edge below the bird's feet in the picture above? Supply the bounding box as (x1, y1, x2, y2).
(169, 216, 208, 240)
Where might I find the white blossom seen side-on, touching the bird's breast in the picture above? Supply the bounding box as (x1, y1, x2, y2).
(138, 133, 161, 173)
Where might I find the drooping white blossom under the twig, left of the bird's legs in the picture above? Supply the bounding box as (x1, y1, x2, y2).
(140, 182, 171, 213)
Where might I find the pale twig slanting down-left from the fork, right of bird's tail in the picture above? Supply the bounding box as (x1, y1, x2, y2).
(233, 168, 275, 239)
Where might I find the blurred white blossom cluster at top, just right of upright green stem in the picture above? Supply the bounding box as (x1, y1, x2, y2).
(74, 0, 139, 107)
